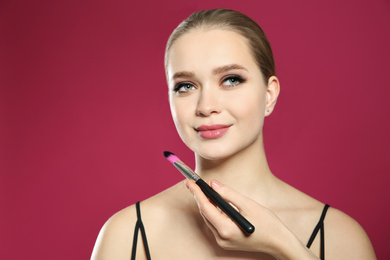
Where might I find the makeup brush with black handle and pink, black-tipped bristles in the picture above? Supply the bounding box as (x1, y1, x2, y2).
(164, 151, 255, 235)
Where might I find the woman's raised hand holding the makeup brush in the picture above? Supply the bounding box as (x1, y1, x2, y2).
(186, 180, 313, 259)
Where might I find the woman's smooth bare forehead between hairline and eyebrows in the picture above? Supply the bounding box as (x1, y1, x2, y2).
(166, 29, 258, 79)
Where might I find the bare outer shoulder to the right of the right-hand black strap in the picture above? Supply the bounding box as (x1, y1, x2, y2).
(324, 207, 376, 260)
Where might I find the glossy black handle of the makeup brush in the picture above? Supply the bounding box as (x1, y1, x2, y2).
(196, 179, 255, 235)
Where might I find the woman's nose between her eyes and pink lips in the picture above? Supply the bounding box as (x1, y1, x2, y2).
(196, 88, 221, 117)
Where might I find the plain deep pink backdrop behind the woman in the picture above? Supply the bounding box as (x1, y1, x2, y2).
(0, 0, 390, 259)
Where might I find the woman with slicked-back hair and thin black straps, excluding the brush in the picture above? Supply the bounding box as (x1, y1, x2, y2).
(92, 9, 375, 260)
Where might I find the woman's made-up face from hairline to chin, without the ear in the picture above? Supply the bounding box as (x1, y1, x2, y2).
(167, 29, 267, 159)
